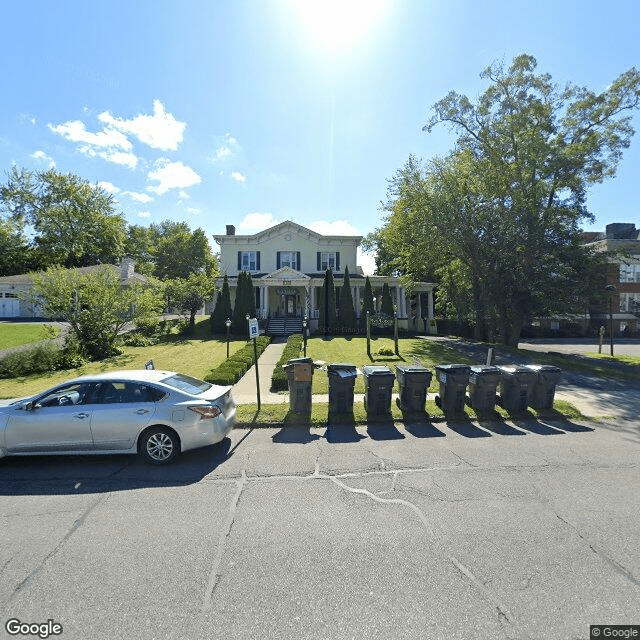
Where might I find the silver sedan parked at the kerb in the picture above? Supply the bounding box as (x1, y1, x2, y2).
(0, 369, 236, 464)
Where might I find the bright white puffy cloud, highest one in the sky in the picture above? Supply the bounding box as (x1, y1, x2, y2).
(98, 100, 187, 151)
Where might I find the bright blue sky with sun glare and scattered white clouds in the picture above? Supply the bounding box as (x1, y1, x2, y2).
(0, 0, 640, 272)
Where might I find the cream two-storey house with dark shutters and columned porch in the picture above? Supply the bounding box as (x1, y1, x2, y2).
(214, 221, 435, 331)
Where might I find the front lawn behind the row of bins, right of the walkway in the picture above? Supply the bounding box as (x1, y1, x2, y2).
(307, 338, 476, 393)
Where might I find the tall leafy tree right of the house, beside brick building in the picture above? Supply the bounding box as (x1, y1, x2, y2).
(368, 55, 640, 344)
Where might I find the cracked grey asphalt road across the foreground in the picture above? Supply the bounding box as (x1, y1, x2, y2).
(0, 421, 640, 640)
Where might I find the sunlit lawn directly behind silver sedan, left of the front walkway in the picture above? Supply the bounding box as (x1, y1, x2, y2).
(0, 318, 247, 398)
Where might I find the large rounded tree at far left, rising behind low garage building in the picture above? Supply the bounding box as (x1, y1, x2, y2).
(0, 167, 126, 267)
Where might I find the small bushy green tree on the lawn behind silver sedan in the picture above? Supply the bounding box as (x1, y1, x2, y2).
(31, 265, 163, 360)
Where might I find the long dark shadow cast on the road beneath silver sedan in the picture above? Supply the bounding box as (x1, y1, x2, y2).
(0, 438, 233, 496)
